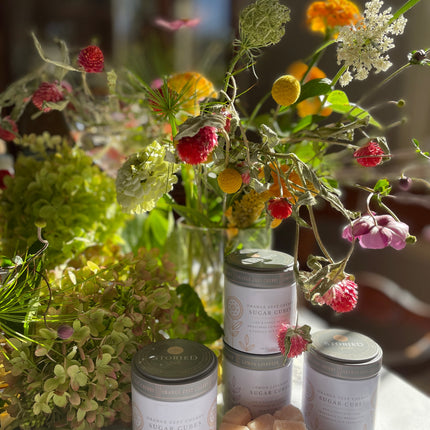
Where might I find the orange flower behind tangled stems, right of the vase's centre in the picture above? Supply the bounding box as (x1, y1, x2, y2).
(269, 164, 318, 203)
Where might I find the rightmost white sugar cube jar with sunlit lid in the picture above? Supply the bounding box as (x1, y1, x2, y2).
(302, 329, 382, 430)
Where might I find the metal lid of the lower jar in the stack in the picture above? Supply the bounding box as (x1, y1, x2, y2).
(223, 342, 291, 371)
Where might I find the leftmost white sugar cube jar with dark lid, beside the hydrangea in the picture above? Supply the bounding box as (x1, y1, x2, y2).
(131, 339, 218, 430)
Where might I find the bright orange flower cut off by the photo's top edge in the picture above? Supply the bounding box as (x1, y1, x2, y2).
(306, 0, 363, 34)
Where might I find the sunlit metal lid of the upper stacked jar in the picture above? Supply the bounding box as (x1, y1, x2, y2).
(224, 249, 294, 288)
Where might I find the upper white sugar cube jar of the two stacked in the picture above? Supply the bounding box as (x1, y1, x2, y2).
(224, 249, 297, 354)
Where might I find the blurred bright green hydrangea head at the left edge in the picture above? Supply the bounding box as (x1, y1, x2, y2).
(0, 134, 125, 268)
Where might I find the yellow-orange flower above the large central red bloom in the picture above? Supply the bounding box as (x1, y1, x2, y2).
(167, 72, 217, 116)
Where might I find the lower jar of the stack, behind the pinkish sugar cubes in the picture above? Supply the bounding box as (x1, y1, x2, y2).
(223, 343, 293, 418)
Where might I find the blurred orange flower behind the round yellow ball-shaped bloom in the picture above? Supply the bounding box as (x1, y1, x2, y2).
(287, 61, 332, 118)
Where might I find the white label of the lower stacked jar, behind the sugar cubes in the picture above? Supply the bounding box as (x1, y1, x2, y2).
(223, 360, 292, 418)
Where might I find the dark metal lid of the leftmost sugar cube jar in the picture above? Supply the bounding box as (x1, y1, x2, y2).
(132, 339, 218, 401)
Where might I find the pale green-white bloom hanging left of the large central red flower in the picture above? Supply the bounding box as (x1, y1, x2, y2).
(116, 141, 178, 213)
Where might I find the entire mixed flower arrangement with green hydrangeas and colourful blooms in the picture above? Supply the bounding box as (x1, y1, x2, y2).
(0, 0, 430, 429)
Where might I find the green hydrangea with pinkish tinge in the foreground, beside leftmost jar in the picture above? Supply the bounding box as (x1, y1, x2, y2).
(2, 247, 222, 430)
